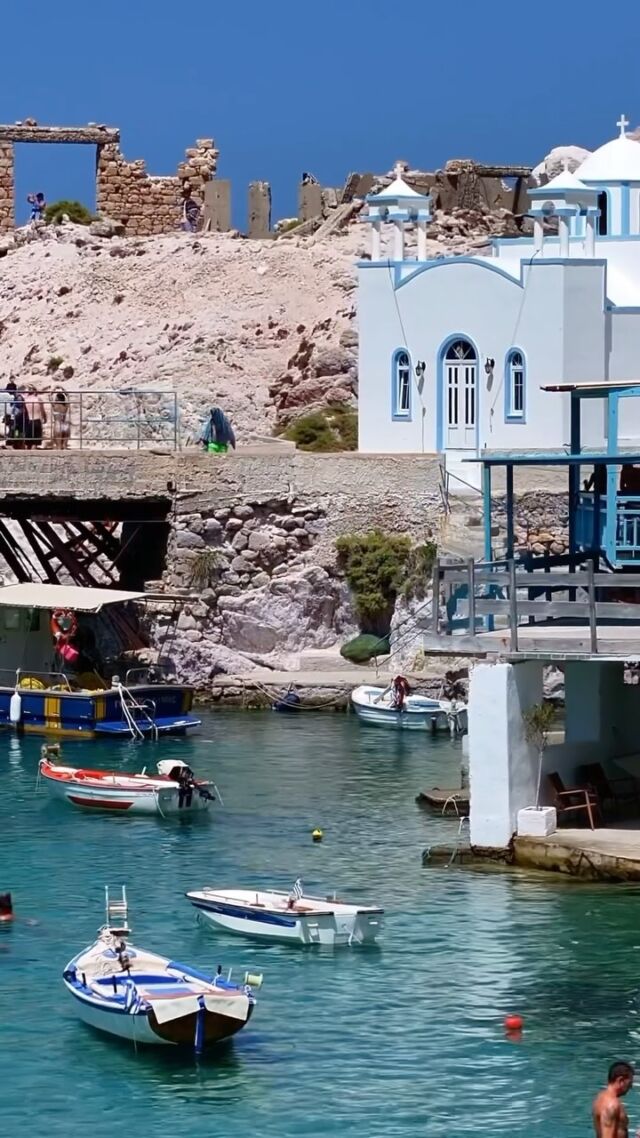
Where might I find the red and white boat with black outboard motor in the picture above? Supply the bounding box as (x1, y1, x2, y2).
(40, 747, 215, 818)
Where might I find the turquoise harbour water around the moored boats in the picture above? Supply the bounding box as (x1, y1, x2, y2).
(0, 712, 640, 1138)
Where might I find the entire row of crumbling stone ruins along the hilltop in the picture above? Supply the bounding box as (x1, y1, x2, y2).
(0, 118, 531, 239)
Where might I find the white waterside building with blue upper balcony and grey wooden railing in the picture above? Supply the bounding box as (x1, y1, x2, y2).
(424, 381, 640, 875)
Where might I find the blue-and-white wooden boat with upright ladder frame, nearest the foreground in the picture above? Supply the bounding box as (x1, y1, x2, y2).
(63, 888, 256, 1054)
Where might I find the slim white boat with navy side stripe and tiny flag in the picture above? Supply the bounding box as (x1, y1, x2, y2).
(186, 880, 384, 947)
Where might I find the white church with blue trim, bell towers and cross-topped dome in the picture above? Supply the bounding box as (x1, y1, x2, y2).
(359, 115, 640, 470)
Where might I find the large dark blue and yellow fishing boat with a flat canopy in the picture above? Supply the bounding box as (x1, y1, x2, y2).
(0, 582, 200, 740)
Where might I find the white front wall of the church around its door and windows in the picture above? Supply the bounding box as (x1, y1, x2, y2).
(359, 258, 563, 453)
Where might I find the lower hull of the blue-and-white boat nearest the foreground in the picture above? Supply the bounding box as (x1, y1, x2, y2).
(67, 984, 253, 1048)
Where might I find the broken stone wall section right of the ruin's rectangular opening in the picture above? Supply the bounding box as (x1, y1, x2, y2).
(97, 139, 219, 237)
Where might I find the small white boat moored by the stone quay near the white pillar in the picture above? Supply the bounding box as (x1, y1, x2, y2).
(351, 684, 467, 735)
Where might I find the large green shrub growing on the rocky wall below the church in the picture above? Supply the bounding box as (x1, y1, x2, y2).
(336, 529, 411, 636)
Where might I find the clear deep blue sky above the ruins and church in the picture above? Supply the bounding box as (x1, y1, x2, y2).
(0, 0, 640, 225)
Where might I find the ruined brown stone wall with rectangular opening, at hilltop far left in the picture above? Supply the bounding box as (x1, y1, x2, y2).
(0, 118, 219, 237)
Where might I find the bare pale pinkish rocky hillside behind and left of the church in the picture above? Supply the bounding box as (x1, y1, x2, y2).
(0, 191, 521, 443)
